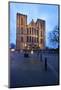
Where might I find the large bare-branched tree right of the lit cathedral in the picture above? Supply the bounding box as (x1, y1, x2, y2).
(49, 25, 59, 48)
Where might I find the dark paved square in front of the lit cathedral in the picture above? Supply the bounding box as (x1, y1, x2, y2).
(10, 52, 59, 87)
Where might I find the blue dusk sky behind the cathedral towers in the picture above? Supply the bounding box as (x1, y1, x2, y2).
(10, 2, 58, 46)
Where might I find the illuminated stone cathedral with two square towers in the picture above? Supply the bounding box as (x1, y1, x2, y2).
(16, 13, 45, 50)
